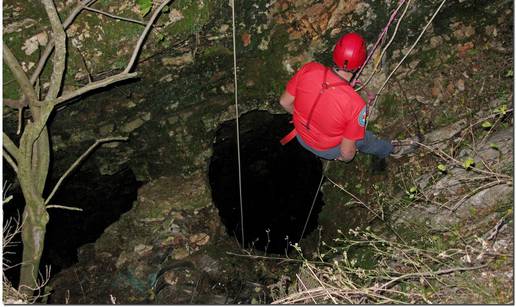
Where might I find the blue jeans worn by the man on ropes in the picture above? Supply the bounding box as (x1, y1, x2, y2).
(296, 131, 392, 160)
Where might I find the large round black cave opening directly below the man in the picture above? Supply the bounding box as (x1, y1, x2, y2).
(209, 111, 323, 253)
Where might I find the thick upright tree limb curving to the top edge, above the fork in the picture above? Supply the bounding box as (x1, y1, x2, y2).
(41, 0, 66, 100)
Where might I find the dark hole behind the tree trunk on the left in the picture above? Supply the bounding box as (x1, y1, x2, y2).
(3, 163, 141, 286)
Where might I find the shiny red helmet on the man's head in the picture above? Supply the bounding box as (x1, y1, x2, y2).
(333, 33, 367, 71)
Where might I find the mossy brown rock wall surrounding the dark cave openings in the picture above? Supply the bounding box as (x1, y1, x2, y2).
(3, 0, 514, 304)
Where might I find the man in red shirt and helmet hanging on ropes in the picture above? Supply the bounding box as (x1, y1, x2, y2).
(280, 33, 393, 162)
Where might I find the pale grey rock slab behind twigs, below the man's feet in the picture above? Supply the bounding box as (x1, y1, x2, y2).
(394, 124, 514, 231)
